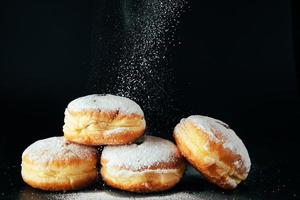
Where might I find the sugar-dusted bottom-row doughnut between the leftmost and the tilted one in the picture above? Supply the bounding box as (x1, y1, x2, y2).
(100, 136, 185, 192)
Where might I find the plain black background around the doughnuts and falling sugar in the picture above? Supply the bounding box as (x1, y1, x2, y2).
(0, 0, 300, 198)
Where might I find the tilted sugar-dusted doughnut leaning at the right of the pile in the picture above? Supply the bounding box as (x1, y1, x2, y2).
(173, 115, 251, 189)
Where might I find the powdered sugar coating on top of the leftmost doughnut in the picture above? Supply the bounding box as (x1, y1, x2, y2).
(22, 137, 97, 163)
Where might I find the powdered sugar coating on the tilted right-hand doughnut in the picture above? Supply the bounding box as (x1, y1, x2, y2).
(183, 115, 251, 171)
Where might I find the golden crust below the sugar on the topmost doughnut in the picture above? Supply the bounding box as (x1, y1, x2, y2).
(63, 108, 146, 145)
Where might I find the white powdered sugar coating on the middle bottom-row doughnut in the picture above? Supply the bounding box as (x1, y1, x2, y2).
(101, 136, 179, 171)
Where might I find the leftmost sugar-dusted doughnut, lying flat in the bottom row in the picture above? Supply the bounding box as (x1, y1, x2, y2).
(21, 137, 98, 191)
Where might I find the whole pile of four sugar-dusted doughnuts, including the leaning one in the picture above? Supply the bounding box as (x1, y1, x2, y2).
(21, 94, 251, 192)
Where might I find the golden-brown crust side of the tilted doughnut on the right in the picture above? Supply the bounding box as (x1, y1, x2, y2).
(173, 116, 249, 189)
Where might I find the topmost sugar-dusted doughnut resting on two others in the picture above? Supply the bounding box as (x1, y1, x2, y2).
(63, 94, 146, 145)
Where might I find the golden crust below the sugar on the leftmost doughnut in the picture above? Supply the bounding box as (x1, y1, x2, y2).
(21, 158, 98, 191)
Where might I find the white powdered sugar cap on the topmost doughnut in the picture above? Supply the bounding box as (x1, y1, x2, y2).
(68, 94, 144, 116)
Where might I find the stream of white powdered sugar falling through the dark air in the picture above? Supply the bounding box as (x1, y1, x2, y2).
(89, 0, 187, 133)
